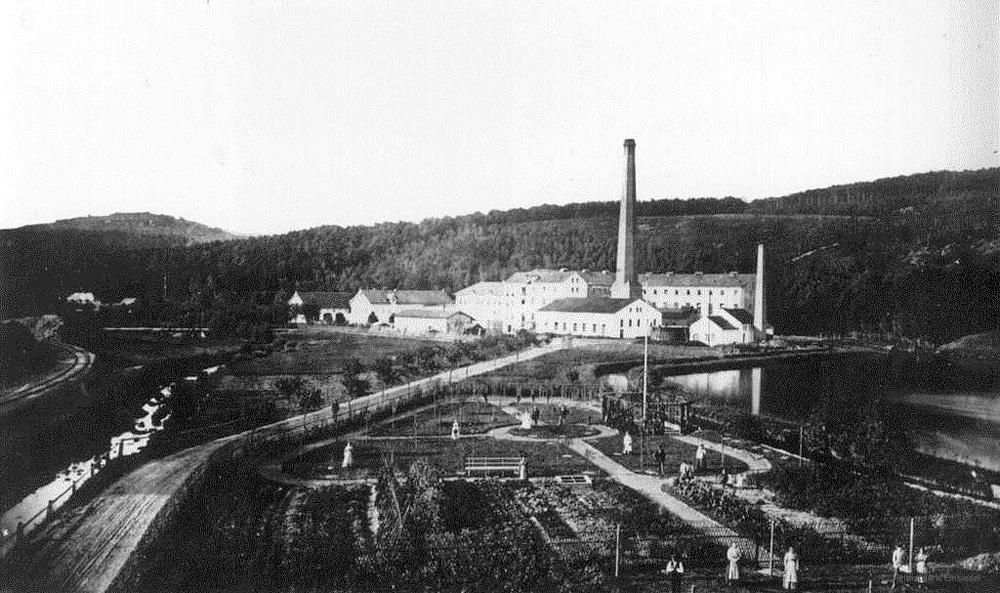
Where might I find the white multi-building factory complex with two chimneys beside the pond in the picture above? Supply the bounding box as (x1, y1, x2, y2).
(455, 140, 767, 346)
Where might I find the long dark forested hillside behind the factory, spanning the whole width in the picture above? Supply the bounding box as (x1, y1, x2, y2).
(0, 169, 1000, 343)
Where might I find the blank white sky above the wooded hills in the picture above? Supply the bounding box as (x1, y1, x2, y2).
(0, 0, 1000, 233)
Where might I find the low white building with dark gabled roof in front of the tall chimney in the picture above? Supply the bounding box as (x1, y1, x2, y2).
(535, 297, 662, 339)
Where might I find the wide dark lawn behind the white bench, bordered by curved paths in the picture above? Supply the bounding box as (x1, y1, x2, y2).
(282, 437, 600, 479)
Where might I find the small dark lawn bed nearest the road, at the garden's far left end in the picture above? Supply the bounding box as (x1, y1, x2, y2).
(367, 400, 518, 436)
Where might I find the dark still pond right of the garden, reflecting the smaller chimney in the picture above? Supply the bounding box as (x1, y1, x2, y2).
(659, 354, 1000, 471)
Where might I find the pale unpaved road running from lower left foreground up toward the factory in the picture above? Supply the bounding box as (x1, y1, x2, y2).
(0, 345, 559, 593)
